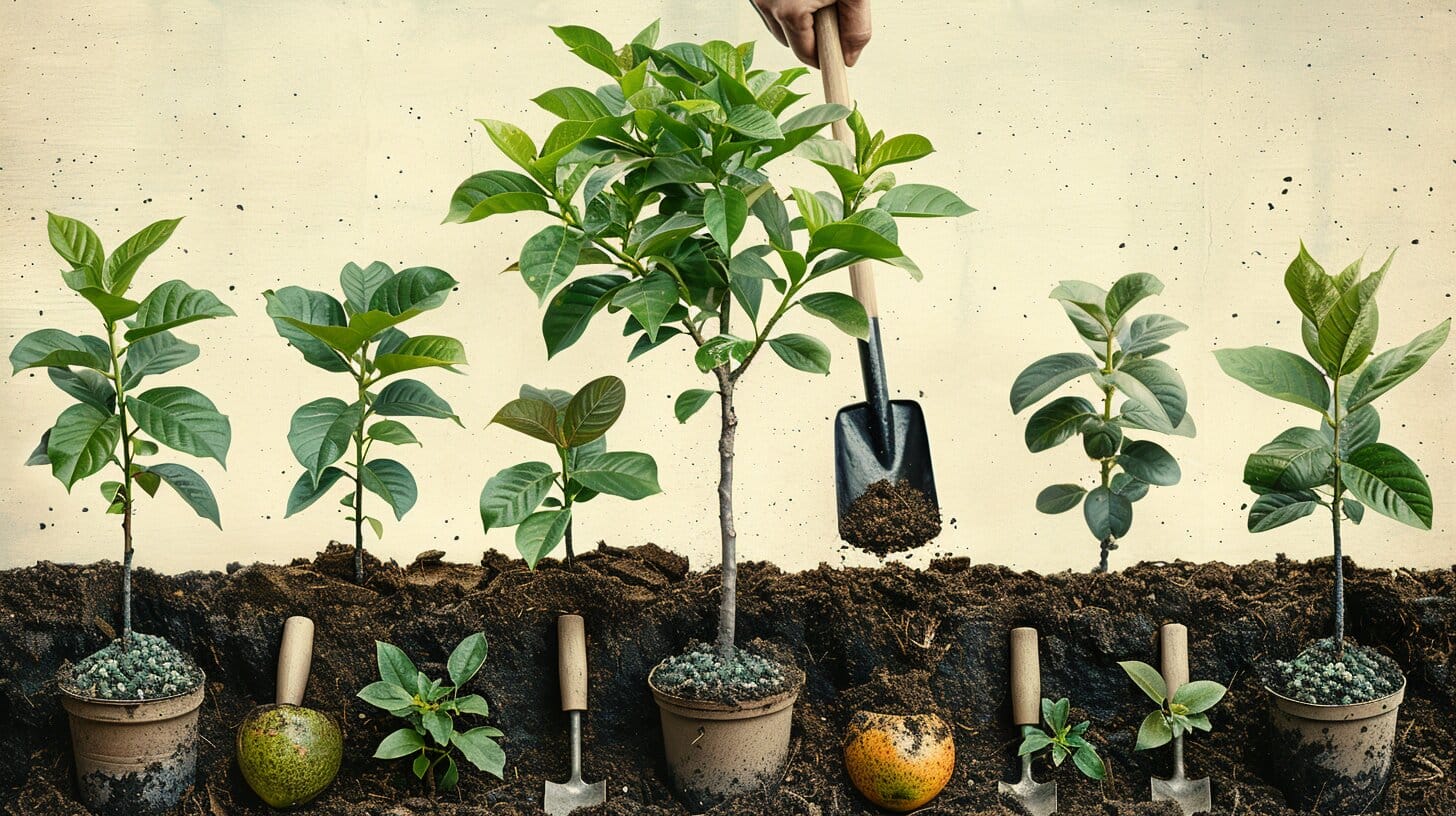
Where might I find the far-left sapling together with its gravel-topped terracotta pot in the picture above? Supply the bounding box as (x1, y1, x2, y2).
(10, 213, 233, 815)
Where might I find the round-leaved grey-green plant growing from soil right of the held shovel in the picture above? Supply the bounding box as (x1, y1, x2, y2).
(1010, 272, 1197, 573)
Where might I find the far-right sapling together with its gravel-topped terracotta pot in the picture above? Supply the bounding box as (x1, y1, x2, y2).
(1214, 245, 1450, 813)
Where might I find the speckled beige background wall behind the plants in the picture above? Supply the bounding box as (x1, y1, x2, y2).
(0, 0, 1456, 570)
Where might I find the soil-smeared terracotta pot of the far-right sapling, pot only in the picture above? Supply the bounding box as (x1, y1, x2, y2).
(1268, 680, 1405, 815)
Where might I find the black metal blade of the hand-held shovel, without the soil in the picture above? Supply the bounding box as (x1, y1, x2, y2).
(834, 399, 941, 519)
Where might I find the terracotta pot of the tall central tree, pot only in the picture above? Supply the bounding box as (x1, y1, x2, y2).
(648, 669, 804, 809)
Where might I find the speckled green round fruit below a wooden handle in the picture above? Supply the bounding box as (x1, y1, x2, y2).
(237, 705, 344, 807)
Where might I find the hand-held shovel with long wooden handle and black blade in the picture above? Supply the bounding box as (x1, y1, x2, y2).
(814, 6, 941, 519)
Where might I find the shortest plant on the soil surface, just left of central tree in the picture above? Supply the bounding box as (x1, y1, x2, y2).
(480, 376, 662, 570)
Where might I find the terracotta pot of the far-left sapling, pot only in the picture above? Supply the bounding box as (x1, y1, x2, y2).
(61, 678, 207, 816)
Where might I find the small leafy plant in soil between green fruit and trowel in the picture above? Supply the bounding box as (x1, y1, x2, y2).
(358, 632, 505, 793)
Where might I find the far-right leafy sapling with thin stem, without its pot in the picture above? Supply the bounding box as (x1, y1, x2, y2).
(1214, 243, 1450, 656)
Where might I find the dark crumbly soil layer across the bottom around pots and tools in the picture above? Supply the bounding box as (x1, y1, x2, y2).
(0, 545, 1456, 816)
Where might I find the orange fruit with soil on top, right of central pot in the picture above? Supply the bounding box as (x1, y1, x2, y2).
(844, 711, 955, 812)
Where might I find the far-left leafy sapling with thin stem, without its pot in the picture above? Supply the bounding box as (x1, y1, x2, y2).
(10, 213, 234, 646)
